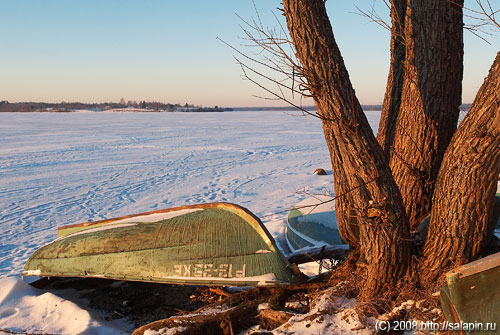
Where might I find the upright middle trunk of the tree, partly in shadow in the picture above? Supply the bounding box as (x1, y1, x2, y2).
(378, 0, 463, 231)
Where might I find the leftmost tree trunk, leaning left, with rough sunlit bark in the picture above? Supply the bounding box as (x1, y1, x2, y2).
(283, 0, 410, 301)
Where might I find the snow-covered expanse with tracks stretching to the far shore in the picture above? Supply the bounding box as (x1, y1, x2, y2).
(0, 112, 392, 334)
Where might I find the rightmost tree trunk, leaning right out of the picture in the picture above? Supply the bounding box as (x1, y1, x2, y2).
(420, 53, 500, 285)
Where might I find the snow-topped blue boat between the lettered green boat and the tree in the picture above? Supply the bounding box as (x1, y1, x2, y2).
(286, 195, 348, 252)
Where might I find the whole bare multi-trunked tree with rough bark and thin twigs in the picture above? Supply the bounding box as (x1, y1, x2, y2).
(238, 0, 500, 301)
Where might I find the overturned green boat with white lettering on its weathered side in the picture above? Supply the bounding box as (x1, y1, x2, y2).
(22, 203, 299, 286)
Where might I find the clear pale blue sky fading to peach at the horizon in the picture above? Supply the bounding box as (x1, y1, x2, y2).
(0, 0, 500, 106)
